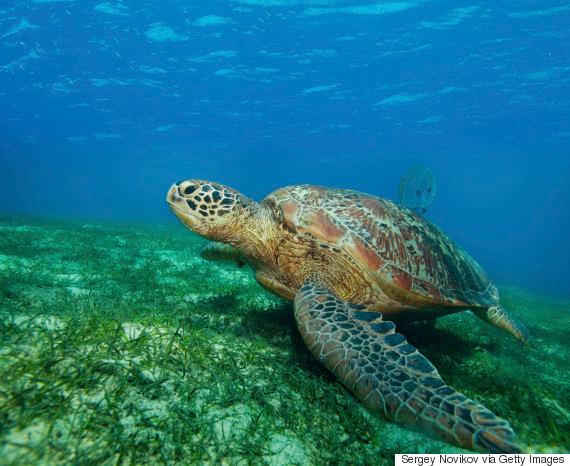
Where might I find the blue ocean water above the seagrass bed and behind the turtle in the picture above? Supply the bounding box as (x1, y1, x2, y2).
(0, 0, 570, 296)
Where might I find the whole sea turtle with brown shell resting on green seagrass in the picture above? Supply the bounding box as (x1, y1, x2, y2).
(166, 179, 528, 453)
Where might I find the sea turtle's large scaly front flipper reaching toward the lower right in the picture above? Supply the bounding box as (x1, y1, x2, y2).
(295, 282, 520, 453)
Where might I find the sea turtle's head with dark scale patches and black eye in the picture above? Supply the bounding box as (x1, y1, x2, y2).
(166, 179, 257, 243)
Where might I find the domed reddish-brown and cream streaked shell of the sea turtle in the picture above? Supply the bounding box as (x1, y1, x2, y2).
(264, 185, 498, 307)
